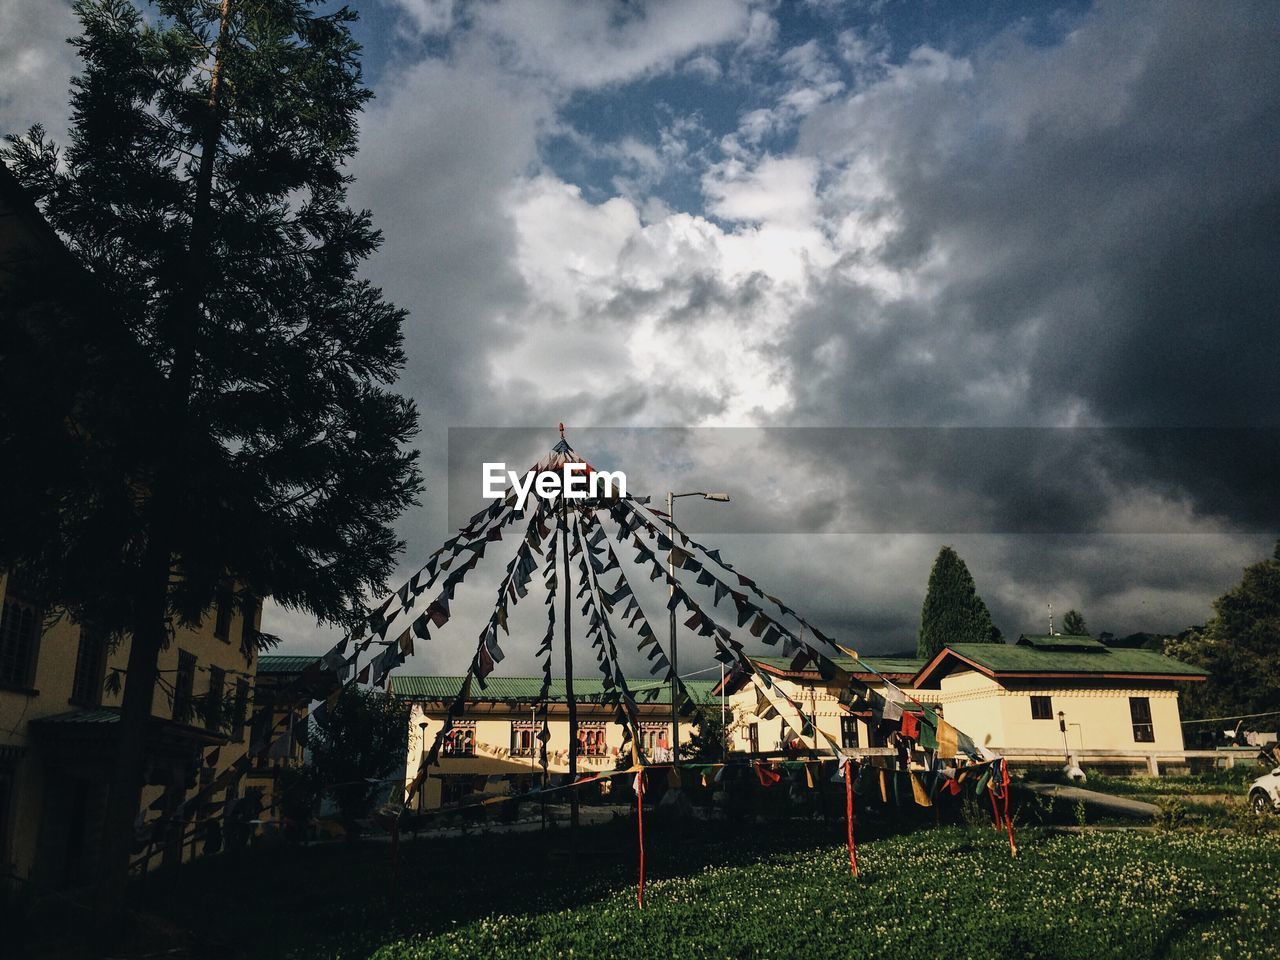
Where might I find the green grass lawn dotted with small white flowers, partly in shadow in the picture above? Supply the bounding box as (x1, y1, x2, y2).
(107, 822, 1280, 960)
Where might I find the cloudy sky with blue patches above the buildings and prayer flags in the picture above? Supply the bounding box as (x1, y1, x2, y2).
(0, 0, 1280, 673)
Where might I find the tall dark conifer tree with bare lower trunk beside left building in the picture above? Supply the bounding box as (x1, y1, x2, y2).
(0, 0, 421, 916)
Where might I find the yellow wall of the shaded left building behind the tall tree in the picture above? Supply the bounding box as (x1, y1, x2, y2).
(0, 576, 261, 878)
